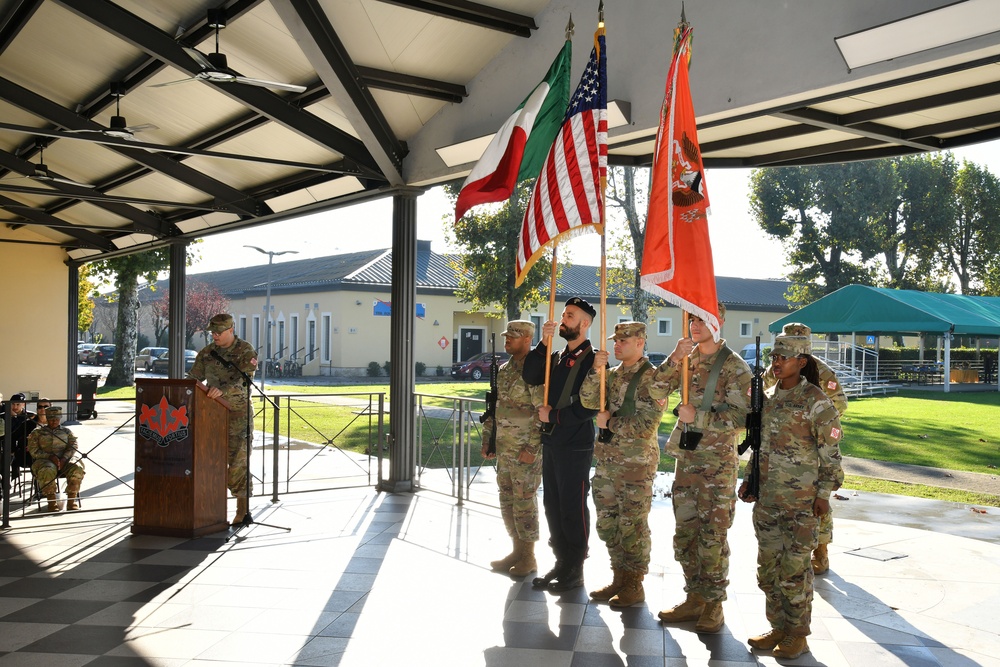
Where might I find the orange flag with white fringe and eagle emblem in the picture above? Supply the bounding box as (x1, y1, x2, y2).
(640, 24, 721, 340)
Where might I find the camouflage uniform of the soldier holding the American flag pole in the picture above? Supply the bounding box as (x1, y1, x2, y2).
(580, 350, 665, 574)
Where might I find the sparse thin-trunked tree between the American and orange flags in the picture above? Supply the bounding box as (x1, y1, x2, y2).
(604, 167, 664, 322)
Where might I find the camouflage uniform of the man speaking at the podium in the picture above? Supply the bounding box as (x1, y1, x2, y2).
(187, 320, 257, 498)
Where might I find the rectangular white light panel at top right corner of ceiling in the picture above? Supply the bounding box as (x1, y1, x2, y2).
(834, 0, 1000, 70)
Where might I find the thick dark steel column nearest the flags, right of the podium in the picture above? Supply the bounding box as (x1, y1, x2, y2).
(379, 190, 420, 492)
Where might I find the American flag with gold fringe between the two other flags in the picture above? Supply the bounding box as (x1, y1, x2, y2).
(516, 24, 608, 285)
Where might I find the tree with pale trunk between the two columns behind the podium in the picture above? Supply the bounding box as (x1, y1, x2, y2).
(91, 248, 170, 387)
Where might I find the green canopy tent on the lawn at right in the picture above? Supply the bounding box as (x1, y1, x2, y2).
(768, 285, 1000, 391)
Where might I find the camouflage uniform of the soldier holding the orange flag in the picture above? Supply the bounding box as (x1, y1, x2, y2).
(650, 340, 753, 602)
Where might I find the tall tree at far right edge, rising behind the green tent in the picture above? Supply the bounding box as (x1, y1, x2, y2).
(940, 162, 1000, 294)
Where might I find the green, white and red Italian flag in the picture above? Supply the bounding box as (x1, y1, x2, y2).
(455, 40, 572, 222)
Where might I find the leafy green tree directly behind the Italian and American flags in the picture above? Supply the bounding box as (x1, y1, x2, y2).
(445, 181, 552, 321)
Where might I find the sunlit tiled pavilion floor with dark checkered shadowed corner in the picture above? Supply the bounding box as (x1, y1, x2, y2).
(0, 488, 1000, 667)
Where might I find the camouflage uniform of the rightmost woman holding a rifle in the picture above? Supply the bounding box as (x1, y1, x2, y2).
(753, 377, 844, 637)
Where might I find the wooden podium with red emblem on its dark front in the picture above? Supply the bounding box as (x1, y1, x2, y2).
(132, 379, 229, 537)
